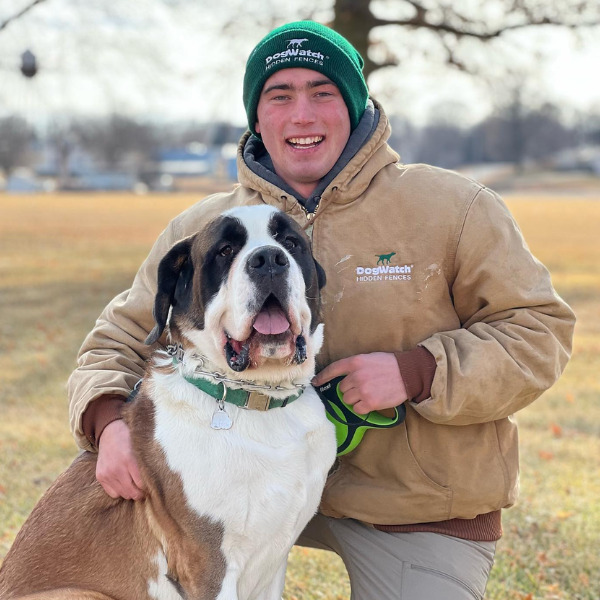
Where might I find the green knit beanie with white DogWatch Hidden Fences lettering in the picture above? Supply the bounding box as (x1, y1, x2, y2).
(244, 21, 369, 135)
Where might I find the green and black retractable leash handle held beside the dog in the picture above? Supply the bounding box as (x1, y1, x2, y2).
(316, 377, 406, 456)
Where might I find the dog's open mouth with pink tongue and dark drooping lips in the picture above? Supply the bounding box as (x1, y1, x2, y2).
(224, 294, 306, 372)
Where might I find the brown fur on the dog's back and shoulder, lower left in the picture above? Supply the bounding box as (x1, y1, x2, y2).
(0, 388, 225, 600)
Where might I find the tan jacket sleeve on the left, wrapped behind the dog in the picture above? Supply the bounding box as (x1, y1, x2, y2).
(67, 222, 180, 450)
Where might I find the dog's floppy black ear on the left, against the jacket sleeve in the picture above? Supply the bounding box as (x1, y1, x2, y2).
(145, 236, 193, 346)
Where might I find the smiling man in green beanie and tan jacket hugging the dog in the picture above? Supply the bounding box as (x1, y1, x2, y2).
(69, 21, 574, 600)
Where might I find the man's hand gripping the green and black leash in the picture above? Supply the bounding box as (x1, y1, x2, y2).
(312, 352, 408, 415)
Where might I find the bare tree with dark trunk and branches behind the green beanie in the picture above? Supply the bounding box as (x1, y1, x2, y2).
(332, 0, 600, 76)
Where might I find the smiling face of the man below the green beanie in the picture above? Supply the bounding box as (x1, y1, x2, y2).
(256, 68, 350, 197)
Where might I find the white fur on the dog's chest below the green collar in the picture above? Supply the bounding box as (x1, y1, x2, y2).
(148, 374, 335, 600)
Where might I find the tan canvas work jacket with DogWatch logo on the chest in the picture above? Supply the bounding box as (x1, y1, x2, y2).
(69, 106, 575, 524)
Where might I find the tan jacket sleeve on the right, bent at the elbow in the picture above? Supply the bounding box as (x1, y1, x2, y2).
(413, 188, 575, 425)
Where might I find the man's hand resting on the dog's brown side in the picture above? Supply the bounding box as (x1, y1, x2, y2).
(96, 419, 144, 500)
